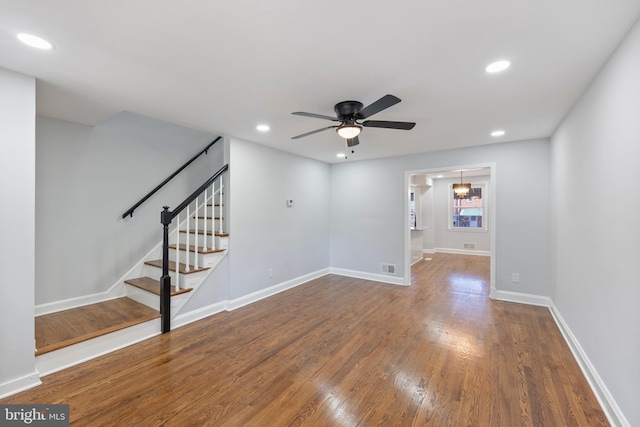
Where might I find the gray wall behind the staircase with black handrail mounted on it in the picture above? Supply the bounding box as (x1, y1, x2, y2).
(35, 113, 223, 304)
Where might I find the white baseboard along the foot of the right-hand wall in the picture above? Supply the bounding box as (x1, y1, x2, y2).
(549, 301, 631, 427)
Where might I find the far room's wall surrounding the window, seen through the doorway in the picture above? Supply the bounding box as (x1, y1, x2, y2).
(433, 176, 491, 252)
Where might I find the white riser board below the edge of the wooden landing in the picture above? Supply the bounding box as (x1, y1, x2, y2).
(36, 319, 160, 376)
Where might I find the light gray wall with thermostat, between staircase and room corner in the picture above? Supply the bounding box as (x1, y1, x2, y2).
(228, 138, 331, 300)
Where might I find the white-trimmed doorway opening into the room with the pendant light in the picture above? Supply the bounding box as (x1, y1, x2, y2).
(404, 163, 496, 297)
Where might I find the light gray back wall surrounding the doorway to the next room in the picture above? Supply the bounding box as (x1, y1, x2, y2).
(331, 139, 552, 296)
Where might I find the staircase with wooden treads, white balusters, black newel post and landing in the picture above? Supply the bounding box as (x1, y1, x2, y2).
(36, 160, 229, 375)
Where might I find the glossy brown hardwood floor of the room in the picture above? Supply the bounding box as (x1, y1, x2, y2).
(1, 254, 608, 427)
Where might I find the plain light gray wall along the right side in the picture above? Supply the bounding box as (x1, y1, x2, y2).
(552, 16, 640, 425)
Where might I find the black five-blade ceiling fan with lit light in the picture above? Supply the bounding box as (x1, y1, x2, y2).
(291, 95, 416, 147)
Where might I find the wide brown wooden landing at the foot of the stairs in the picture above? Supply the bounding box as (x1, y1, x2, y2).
(35, 297, 160, 356)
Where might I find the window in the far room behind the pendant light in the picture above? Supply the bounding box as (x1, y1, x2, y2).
(449, 184, 487, 231)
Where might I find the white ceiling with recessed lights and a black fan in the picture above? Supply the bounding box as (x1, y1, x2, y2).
(0, 0, 640, 162)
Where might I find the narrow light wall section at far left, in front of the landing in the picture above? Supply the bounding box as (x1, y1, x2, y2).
(0, 68, 39, 396)
